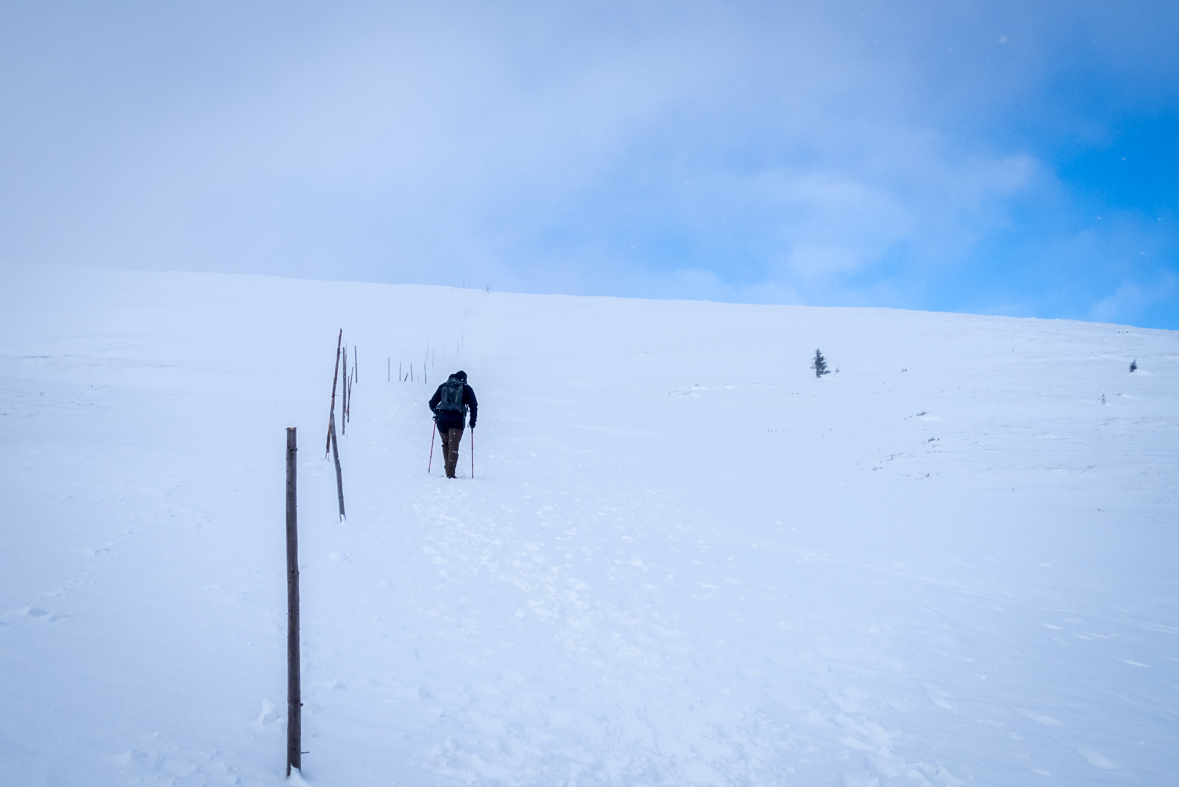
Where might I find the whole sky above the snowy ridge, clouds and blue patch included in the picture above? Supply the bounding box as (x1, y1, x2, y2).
(0, 0, 1179, 329)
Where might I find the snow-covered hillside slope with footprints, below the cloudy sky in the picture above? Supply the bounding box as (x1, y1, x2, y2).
(0, 270, 1179, 787)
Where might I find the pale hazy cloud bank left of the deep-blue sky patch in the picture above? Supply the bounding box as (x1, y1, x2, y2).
(0, 2, 1169, 325)
